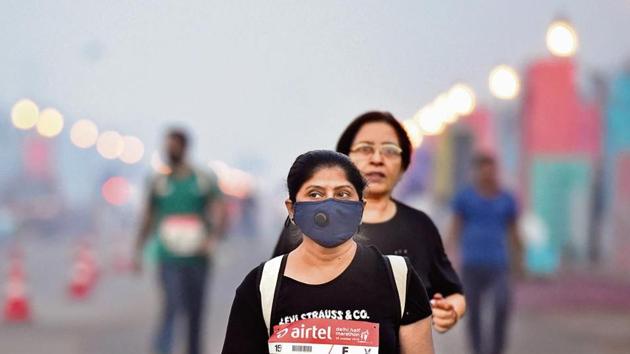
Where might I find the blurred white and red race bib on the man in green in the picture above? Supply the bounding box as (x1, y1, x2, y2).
(159, 214, 206, 256)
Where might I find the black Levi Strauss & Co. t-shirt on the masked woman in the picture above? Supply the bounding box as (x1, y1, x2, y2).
(222, 245, 431, 354)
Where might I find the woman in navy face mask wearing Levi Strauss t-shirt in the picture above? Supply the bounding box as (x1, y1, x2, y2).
(223, 150, 433, 354)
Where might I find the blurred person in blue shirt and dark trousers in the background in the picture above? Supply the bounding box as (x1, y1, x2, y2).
(451, 153, 521, 354)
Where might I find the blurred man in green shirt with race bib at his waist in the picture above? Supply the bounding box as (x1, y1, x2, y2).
(135, 130, 226, 354)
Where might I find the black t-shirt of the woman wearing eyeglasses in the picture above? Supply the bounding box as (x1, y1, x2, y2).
(273, 200, 463, 297)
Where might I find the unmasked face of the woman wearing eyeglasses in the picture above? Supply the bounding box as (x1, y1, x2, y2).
(349, 122, 403, 196)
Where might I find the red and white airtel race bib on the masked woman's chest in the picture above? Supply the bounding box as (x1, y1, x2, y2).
(269, 319, 379, 354)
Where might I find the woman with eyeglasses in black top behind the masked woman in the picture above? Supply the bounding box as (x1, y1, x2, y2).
(274, 112, 466, 333)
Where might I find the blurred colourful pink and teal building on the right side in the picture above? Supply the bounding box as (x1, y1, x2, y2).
(397, 57, 630, 275)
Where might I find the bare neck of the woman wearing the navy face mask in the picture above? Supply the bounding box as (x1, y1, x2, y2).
(299, 237, 357, 268)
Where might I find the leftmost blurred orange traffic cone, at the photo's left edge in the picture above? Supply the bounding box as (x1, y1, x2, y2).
(4, 250, 31, 322)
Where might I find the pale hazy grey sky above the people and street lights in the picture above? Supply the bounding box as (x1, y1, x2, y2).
(0, 0, 630, 180)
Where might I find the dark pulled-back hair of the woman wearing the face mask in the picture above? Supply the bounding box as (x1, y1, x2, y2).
(287, 150, 367, 203)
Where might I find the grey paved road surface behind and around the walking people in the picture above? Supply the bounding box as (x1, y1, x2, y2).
(0, 232, 630, 354)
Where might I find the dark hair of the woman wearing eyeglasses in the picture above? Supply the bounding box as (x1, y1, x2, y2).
(337, 111, 412, 171)
